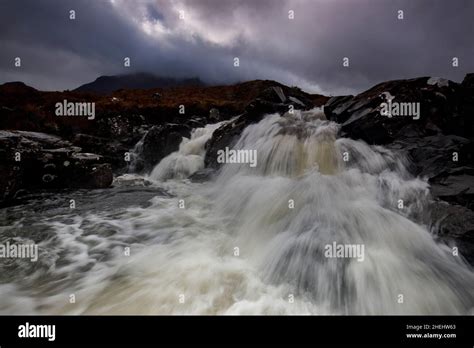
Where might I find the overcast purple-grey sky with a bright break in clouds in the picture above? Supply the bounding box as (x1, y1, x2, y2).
(0, 0, 474, 95)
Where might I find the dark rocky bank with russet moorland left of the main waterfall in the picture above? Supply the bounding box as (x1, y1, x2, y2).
(0, 81, 327, 205)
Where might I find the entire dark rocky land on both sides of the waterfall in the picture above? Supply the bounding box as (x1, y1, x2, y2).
(0, 74, 474, 262)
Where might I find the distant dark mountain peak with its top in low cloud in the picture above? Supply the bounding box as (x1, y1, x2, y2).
(75, 73, 204, 94)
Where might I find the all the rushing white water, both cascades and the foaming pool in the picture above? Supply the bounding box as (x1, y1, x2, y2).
(0, 109, 474, 314)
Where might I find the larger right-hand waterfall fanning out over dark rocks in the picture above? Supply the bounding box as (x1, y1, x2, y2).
(208, 110, 474, 314)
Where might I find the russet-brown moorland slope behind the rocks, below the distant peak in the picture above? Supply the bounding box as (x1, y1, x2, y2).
(0, 79, 329, 135)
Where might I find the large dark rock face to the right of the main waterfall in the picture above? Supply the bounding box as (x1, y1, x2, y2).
(324, 75, 474, 193)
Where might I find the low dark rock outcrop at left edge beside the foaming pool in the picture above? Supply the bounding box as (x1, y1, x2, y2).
(0, 131, 113, 204)
